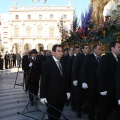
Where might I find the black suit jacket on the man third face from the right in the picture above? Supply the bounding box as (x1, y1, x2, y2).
(72, 53, 85, 84)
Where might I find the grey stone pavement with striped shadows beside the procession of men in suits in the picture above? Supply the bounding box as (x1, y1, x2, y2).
(0, 68, 88, 120)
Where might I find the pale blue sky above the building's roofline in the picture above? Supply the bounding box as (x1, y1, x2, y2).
(0, 0, 90, 18)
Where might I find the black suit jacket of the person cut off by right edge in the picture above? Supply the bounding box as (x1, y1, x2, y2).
(115, 61, 120, 100)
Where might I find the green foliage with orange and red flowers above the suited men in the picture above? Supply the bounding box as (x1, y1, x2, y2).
(62, 17, 120, 47)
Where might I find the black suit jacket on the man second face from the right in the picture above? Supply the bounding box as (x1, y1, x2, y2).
(81, 54, 98, 88)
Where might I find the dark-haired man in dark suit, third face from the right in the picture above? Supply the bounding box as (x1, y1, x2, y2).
(72, 44, 90, 118)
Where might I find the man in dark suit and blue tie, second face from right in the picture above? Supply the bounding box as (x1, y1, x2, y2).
(81, 45, 102, 120)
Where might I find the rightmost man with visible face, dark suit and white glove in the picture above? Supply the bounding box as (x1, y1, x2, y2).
(97, 41, 120, 120)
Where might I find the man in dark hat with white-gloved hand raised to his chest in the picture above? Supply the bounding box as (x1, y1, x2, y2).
(28, 49, 42, 106)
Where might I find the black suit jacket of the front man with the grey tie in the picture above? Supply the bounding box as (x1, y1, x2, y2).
(40, 58, 68, 105)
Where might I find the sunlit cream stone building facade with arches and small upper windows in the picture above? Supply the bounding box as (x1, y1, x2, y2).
(0, 6, 75, 53)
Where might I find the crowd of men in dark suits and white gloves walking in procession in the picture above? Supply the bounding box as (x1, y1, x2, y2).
(0, 41, 120, 120)
